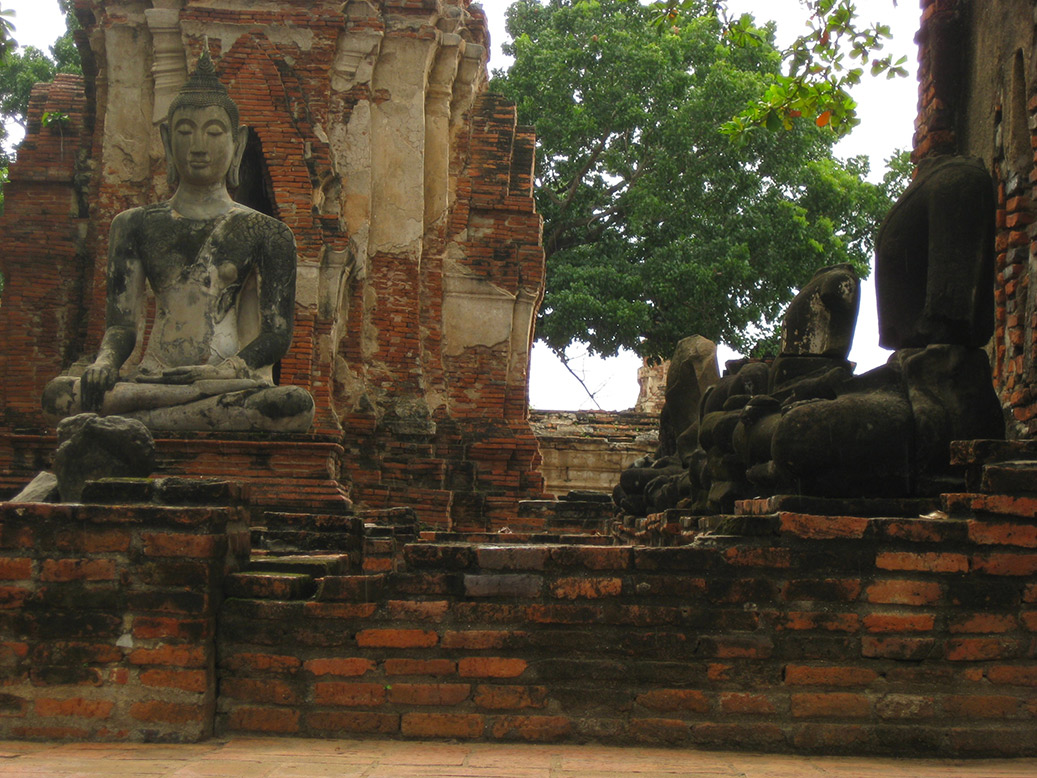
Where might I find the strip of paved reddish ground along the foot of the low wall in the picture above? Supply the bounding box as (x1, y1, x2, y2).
(0, 738, 1037, 778)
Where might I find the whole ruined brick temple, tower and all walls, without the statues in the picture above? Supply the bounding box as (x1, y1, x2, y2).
(0, 0, 1037, 757)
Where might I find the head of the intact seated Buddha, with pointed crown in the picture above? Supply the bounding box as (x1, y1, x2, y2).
(160, 47, 248, 189)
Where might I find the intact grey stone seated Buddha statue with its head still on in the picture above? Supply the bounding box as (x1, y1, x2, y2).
(43, 52, 313, 432)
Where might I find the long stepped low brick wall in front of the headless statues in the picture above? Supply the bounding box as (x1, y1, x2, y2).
(217, 496, 1037, 757)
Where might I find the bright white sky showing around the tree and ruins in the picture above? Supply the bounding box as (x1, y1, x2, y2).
(0, 0, 920, 410)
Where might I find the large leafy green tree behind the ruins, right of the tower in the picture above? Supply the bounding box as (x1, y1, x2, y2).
(494, 0, 890, 359)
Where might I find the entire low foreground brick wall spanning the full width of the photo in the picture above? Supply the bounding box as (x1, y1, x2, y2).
(0, 481, 1037, 756)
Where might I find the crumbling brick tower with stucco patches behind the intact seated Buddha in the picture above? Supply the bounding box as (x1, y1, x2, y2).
(0, 0, 543, 528)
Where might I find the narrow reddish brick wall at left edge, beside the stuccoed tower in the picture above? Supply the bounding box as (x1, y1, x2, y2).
(0, 75, 93, 485)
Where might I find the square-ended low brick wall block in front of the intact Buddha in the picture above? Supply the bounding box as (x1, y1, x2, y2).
(0, 494, 249, 742)
